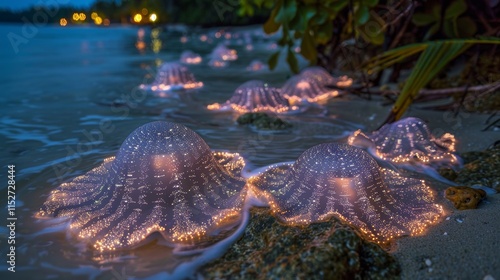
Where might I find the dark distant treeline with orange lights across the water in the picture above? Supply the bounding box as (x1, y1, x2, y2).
(0, 0, 269, 27)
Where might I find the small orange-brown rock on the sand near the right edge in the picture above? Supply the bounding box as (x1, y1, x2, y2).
(445, 187, 486, 210)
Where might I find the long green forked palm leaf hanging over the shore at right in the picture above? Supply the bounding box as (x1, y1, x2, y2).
(367, 38, 500, 123)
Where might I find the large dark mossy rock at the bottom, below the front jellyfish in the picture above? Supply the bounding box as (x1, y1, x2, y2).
(201, 208, 400, 279)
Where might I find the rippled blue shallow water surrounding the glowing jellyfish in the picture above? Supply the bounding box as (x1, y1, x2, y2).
(0, 25, 496, 279)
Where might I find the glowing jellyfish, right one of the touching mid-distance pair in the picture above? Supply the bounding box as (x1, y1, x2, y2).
(281, 75, 339, 104)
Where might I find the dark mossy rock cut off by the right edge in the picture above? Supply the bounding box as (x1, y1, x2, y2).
(454, 146, 500, 191)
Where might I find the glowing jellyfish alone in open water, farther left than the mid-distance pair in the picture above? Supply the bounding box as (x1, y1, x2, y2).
(140, 62, 203, 91)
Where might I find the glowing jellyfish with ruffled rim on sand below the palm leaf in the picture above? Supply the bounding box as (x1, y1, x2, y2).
(348, 117, 461, 175)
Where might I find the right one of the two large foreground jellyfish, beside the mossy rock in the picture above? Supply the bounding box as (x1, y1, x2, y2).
(248, 143, 443, 243)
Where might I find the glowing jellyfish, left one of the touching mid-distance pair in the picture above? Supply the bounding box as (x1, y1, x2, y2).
(207, 80, 295, 113)
